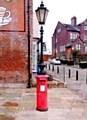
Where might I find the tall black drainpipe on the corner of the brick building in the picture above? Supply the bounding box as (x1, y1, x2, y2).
(27, 0, 31, 88)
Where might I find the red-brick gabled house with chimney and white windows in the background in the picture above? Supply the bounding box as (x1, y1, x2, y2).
(52, 16, 87, 59)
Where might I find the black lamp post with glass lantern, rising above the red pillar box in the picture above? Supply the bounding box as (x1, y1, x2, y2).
(35, 1, 48, 74)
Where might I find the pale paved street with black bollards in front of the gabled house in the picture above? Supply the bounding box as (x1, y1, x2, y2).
(45, 65, 87, 100)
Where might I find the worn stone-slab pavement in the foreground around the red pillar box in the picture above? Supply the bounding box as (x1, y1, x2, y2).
(0, 83, 87, 120)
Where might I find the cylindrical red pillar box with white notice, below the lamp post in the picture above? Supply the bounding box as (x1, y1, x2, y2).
(36, 75, 48, 111)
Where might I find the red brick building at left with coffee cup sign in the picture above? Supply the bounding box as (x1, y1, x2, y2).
(0, 0, 33, 83)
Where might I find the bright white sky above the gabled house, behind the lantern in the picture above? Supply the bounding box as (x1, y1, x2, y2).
(33, 0, 87, 51)
